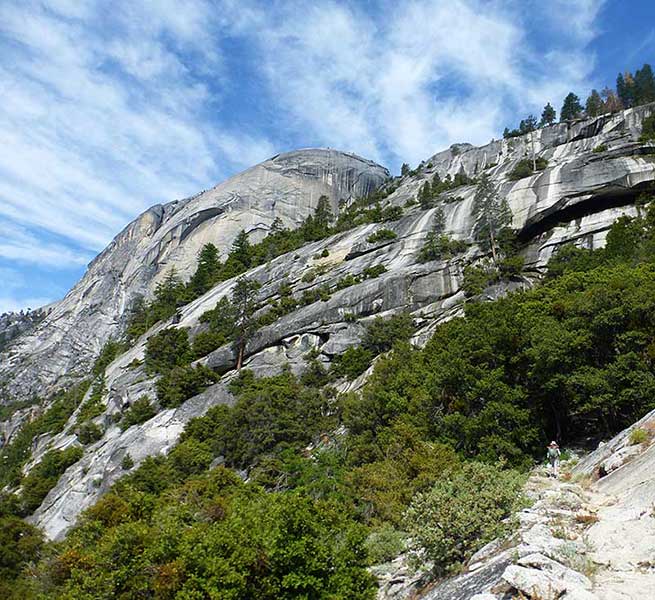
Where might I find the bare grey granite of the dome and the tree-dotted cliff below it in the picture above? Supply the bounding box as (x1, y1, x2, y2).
(0, 105, 655, 538)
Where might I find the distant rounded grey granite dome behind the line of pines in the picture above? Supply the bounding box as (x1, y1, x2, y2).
(0, 149, 389, 401)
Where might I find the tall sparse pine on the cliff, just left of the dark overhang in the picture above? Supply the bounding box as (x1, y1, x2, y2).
(472, 174, 512, 265)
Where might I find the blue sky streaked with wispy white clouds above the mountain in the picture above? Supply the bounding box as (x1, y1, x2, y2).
(0, 0, 655, 313)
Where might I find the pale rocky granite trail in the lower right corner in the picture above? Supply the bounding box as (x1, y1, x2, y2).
(378, 411, 655, 600)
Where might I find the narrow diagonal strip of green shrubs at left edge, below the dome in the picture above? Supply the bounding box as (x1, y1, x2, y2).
(0, 381, 89, 487)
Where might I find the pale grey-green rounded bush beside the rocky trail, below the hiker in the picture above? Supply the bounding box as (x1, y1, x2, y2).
(405, 462, 525, 575)
